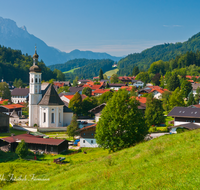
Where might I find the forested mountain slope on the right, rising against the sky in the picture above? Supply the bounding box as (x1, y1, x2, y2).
(118, 33, 200, 75)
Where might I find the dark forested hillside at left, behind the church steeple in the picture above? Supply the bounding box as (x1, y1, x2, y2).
(0, 45, 65, 83)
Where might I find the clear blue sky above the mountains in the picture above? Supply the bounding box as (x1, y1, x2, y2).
(0, 0, 200, 56)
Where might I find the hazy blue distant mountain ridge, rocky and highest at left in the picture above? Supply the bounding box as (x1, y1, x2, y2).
(0, 17, 122, 65)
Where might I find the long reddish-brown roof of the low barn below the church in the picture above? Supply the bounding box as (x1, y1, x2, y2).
(1, 134, 65, 145)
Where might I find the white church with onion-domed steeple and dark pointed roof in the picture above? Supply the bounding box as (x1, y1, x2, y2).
(29, 49, 73, 128)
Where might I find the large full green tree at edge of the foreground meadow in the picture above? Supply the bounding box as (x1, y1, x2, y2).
(95, 90, 148, 152)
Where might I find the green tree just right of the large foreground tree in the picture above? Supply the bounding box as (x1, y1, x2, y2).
(145, 96, 165, 127)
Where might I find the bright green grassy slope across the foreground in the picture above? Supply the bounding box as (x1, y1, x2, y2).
(0, 130, 200, 190)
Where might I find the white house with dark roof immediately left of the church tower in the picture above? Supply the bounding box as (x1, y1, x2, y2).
(11, 88, 29, 103)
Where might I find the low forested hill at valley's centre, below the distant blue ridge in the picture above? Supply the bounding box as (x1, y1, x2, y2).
(49, 59, 114, 80)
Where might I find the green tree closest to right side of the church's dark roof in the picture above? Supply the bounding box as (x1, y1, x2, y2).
(69, 92, 82, 115)
